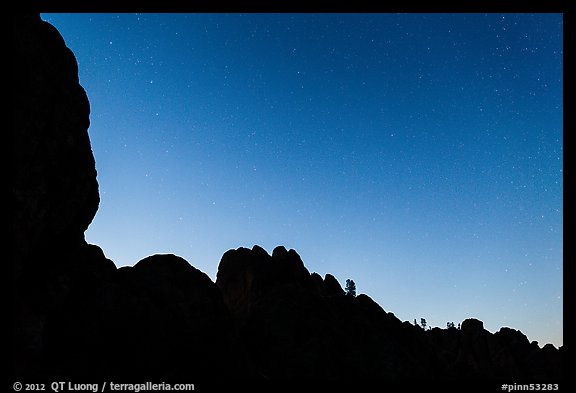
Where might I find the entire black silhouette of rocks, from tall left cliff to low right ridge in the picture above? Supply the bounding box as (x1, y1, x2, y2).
(11, 14, 563, 382)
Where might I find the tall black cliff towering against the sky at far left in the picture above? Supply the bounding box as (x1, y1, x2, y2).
(10, 15, 102, 374)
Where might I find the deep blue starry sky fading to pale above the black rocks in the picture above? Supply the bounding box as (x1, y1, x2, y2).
(42, 13, 563, 346)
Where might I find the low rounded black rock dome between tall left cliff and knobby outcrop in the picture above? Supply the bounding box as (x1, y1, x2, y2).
(44, 255, 251, 382)
